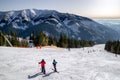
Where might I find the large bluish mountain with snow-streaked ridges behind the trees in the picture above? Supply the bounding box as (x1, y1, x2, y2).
(0, 9, 119, 43)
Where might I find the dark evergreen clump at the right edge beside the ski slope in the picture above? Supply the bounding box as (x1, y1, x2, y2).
(105, 41, 120, 55)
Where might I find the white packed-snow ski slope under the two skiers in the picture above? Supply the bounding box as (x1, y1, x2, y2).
(0, 44, 120, 80)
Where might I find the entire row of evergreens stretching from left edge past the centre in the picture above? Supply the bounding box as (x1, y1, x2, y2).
(0, 31, 95, 48)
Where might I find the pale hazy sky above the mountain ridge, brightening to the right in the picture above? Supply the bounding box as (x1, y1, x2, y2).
(0, 0, 120, 18)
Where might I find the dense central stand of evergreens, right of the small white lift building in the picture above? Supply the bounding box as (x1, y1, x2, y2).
(30, 31, 95, 48)
